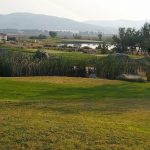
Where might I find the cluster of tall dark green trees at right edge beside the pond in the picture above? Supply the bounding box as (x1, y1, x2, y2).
(113, 23, 150, 55)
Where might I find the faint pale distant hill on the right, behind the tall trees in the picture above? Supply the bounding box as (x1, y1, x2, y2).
(84, 20, 150, 29)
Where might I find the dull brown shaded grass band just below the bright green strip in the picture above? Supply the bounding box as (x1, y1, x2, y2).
(0, 98, 150, 115)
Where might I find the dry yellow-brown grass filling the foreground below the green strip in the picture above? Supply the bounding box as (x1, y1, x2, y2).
(0, 100, 150, 150)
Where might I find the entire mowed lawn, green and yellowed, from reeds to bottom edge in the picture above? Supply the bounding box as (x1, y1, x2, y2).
(0, 77, 150, 150)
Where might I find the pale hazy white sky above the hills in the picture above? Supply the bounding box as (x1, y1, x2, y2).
(0, 0, 150, 21)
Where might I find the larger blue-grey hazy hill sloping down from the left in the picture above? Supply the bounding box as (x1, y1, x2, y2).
(0, 13, 116, 34)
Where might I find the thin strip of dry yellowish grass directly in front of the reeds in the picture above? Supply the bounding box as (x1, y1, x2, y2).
(0, 76, 122, 87)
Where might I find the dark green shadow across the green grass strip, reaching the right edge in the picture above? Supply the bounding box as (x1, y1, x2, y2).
(36, 83, 150, 100)
